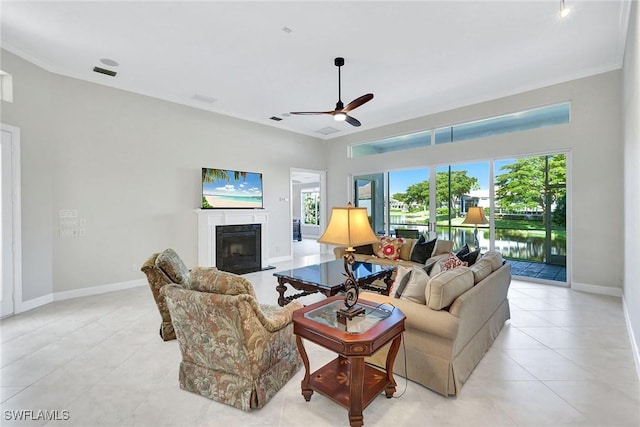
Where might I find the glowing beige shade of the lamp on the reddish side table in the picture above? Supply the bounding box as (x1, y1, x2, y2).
(318, 203, 378, 248)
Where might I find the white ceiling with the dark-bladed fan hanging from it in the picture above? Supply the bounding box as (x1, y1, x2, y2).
(0, 0, 630, 138)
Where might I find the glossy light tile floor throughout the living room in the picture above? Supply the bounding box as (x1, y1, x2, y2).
(0, 254, 640, 427)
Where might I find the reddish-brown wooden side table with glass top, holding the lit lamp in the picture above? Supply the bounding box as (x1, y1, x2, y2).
(293, 297, 405, 426)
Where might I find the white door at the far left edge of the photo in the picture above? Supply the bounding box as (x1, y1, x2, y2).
(0, 124, 22, 317)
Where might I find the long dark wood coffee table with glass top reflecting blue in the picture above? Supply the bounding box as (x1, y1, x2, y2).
(273, 259, 396, 306)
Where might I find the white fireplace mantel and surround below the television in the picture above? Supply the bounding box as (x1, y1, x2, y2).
(194, 209, 271, 268)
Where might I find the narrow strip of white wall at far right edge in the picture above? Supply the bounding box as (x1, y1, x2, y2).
(623, 2, 640, 370)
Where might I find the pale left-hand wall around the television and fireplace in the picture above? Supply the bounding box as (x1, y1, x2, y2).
(1, 51, 325, 301)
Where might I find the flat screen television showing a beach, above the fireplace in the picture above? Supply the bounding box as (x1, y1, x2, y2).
(202, 168, 263, 209)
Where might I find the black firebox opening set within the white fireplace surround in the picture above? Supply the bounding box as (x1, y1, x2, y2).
(216, 224, 262, 274)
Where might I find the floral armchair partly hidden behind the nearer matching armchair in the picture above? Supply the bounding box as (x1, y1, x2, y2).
(141, 249, 189, 341)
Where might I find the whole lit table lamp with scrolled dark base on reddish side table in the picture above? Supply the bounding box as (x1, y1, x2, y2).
(318, 203, 378, 320)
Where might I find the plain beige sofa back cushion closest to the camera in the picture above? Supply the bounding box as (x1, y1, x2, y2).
(425, 266, 473, 310)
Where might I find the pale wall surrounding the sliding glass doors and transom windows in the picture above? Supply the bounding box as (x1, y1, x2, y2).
(327, 71, 624, 295)
